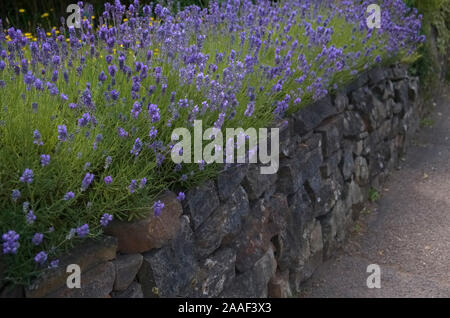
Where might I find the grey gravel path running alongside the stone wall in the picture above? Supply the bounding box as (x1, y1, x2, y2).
(302, 89, 450, 297)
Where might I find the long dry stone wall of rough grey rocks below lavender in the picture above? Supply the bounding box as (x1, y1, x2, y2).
(2, 65, 422, 297)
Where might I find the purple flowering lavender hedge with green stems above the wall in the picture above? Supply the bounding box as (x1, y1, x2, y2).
(0, 0, 424, 283)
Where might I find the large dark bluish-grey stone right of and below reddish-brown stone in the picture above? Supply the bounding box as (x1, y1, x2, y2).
(137, 216, 200, 297)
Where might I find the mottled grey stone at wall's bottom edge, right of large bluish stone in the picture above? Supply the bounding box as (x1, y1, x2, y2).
(201, 248, 236, 297)
